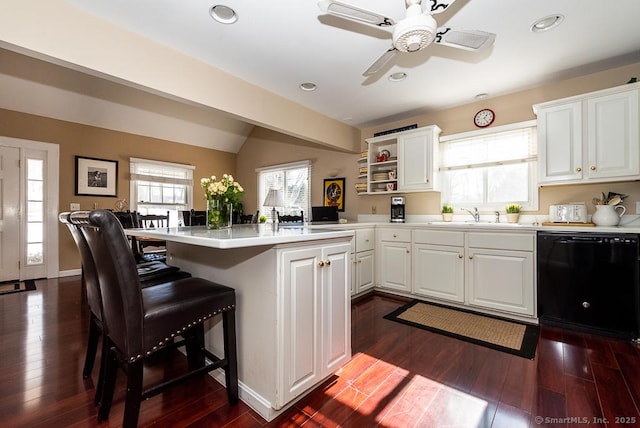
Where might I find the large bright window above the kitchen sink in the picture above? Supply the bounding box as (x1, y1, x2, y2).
(440, 121, 538, 211)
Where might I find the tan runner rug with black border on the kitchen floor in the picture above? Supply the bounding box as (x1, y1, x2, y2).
(384, 300, 540, 359)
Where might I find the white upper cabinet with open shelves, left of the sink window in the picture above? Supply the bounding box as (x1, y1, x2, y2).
(366, 125, 441, 193)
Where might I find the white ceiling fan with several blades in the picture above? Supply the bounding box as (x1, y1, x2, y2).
(318, 0, 496, 76)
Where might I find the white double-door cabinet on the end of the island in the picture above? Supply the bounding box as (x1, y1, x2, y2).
(277, 243, 351, 406)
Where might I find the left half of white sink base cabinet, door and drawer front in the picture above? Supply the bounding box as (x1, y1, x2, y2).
(412, 230, 465, 303)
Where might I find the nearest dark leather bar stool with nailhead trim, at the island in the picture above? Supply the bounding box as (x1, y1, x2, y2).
(69, 210, 238, 427)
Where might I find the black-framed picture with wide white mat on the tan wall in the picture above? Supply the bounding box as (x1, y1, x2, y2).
(76, 156, 118, 198)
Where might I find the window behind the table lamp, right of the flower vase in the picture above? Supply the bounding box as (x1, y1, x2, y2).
(256, 161, 311, 221)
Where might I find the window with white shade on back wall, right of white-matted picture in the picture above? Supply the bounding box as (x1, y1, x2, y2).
(130, 158, 195, 227)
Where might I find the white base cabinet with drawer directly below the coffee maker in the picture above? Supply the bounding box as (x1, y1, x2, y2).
(376, 228, 411, 292)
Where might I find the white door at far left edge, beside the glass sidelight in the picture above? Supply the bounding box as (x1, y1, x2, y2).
(0, 146, 21, 281)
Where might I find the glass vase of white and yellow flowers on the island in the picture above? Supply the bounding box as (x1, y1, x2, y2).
(200, 174, 244, 229)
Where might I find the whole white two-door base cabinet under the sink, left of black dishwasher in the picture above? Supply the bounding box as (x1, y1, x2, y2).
(412, 229, 535, 317)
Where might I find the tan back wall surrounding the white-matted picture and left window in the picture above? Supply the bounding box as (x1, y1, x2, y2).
(0, 109, 236, 271)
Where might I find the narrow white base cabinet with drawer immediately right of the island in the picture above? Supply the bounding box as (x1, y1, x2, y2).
(351, 228, 375, 296)
